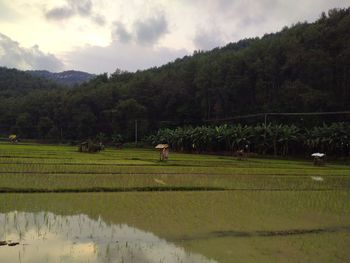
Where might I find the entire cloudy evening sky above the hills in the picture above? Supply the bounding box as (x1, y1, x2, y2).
(0, 0, 350, 74)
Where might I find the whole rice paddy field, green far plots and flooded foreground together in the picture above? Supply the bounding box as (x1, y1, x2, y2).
(0, 143, 350, 263)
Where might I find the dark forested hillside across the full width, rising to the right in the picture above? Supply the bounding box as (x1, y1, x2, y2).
(0, 8, 350, 138)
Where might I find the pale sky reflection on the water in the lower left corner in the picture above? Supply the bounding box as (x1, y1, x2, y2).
(0, 212, 215, 263)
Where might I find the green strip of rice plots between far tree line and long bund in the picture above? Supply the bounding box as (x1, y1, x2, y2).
(0, 144, 350, 192)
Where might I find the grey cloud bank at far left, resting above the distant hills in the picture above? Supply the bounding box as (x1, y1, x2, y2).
(0, 33, 64, 71)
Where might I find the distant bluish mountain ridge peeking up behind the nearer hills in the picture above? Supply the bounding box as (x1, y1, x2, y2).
(25, 70, 96, 86)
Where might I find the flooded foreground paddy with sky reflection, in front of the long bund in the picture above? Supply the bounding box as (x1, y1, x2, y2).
(0, 191, 350, 263)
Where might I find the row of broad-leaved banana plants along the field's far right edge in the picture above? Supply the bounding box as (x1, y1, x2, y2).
(147, 123, 350, 156)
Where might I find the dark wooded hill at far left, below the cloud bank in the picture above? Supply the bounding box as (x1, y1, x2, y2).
(0, 67, 59, 99)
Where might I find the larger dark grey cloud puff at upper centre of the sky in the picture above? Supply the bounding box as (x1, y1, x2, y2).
(134, 15, 168, 44)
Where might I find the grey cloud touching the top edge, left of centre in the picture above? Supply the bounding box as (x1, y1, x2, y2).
(45, 0, 102, 26)
